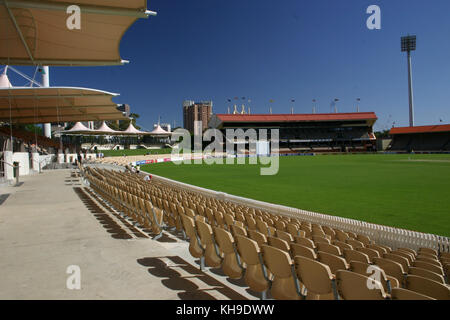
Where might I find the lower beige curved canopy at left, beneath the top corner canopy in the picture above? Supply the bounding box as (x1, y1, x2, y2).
(0, 87, 128, 124)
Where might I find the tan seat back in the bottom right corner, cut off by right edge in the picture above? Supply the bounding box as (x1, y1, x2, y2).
(405, 275, 450, 300)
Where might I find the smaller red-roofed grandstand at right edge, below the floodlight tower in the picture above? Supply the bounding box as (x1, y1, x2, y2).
(388, 124, 450, 152)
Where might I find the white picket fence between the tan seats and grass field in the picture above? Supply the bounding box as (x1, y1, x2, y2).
(152, 174, 450, 252)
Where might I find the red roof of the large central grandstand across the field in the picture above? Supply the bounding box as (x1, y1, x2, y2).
(213, 112, 378, 127)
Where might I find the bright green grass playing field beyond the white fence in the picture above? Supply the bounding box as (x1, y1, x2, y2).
(142, 155, 450, 236)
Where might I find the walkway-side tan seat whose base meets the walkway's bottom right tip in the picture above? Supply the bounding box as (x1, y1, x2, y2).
(235, 235, 270, 299)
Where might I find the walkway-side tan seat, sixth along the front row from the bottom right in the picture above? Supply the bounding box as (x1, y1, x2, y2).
(214, 227, 243, 279)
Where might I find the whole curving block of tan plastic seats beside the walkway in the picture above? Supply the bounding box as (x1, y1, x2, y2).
(82, 168, 450, 300)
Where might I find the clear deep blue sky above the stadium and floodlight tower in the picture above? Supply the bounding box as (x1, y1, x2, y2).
(3, 0, 450, 130)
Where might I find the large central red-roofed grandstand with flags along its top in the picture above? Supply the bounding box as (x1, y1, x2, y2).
(209, 112, 377, 153)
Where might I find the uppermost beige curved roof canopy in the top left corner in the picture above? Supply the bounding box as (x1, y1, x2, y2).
(0, 0, 156, 66)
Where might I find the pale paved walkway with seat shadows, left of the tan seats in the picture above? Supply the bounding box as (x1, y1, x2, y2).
(0, 170, 256, 299)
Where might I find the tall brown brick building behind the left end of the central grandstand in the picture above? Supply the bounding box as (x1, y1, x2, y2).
(183, 100, 212, 133)
